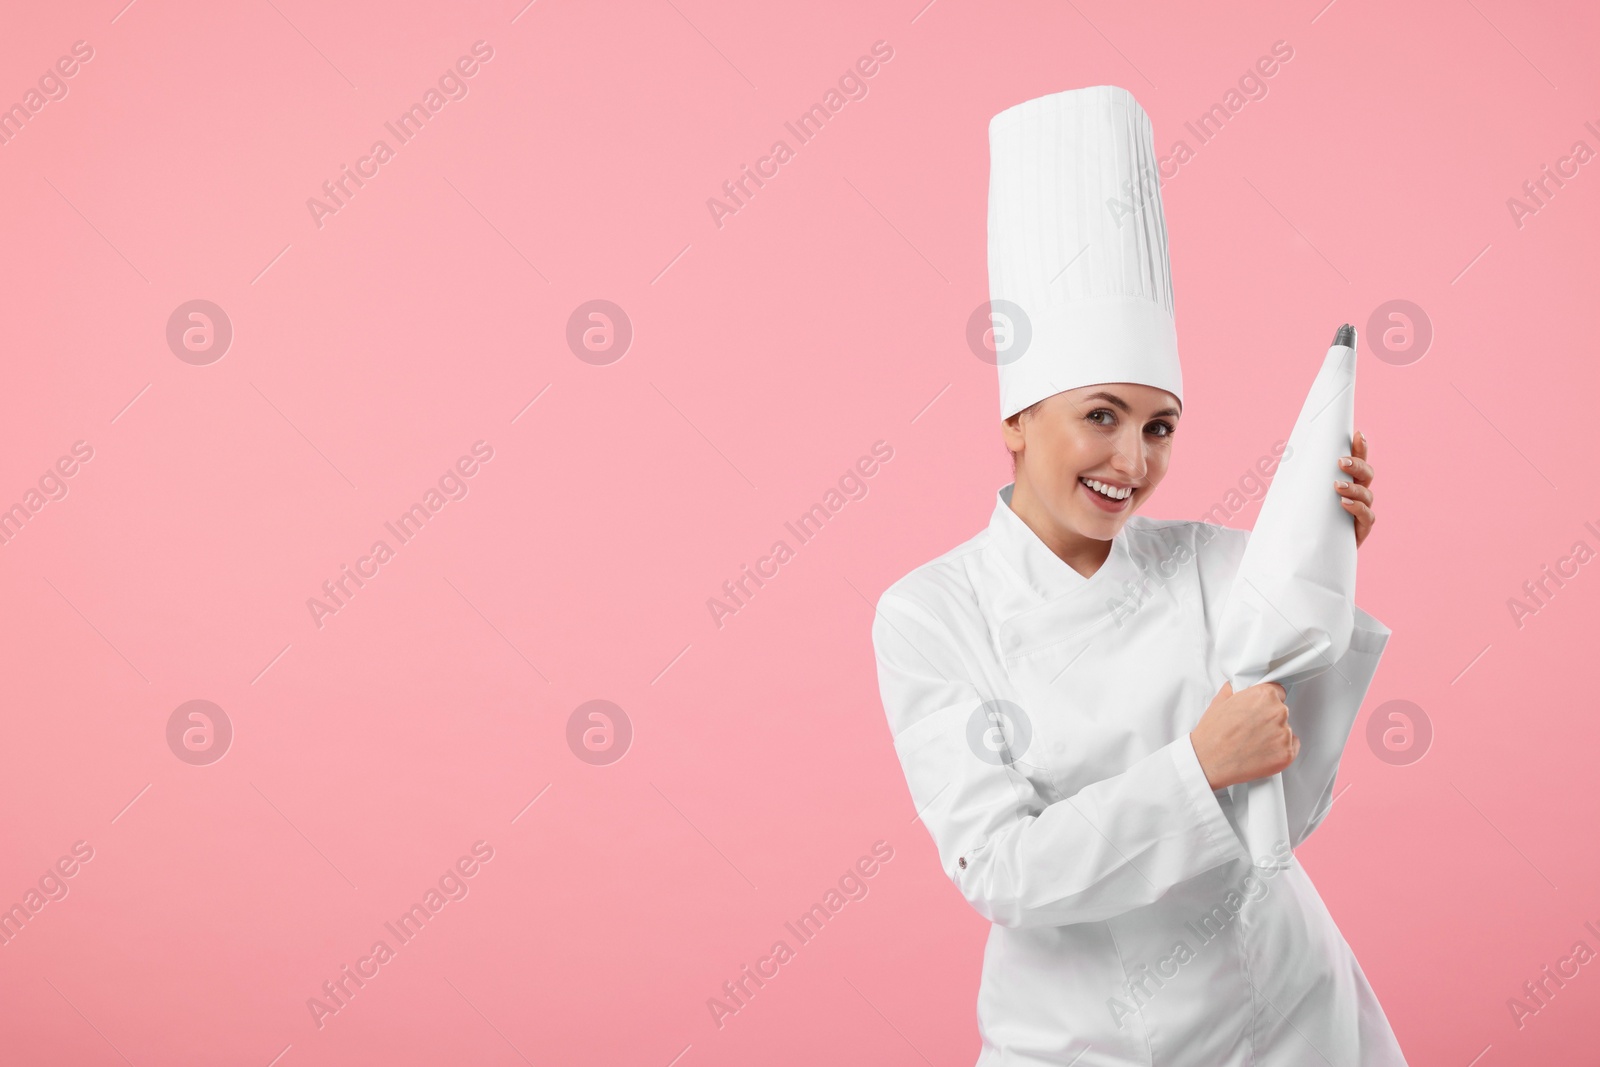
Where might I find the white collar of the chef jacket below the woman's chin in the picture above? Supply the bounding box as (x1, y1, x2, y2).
(989, 482, 1139, 654)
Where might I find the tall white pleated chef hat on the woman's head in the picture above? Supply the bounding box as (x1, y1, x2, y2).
(989, 85, 1184, 418)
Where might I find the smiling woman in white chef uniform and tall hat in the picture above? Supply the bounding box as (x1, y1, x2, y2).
(872, 86, 1405, 1067)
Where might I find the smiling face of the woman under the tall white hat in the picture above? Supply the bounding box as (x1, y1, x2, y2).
(1003, 382, 1181, 541)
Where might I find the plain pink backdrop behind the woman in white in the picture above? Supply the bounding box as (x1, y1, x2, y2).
(0, 0, 1600, 1067)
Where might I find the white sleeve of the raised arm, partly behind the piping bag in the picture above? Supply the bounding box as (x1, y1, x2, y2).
(1283, 606, 1390, 848)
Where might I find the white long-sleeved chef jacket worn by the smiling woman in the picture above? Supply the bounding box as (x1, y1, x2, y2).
(872, 485, 1405, 1067)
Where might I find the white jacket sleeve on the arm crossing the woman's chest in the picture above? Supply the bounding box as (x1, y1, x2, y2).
(872, 593, 1248, 926)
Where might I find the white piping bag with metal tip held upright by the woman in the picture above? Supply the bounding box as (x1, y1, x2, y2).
(1216, 325, 1355, 869)
